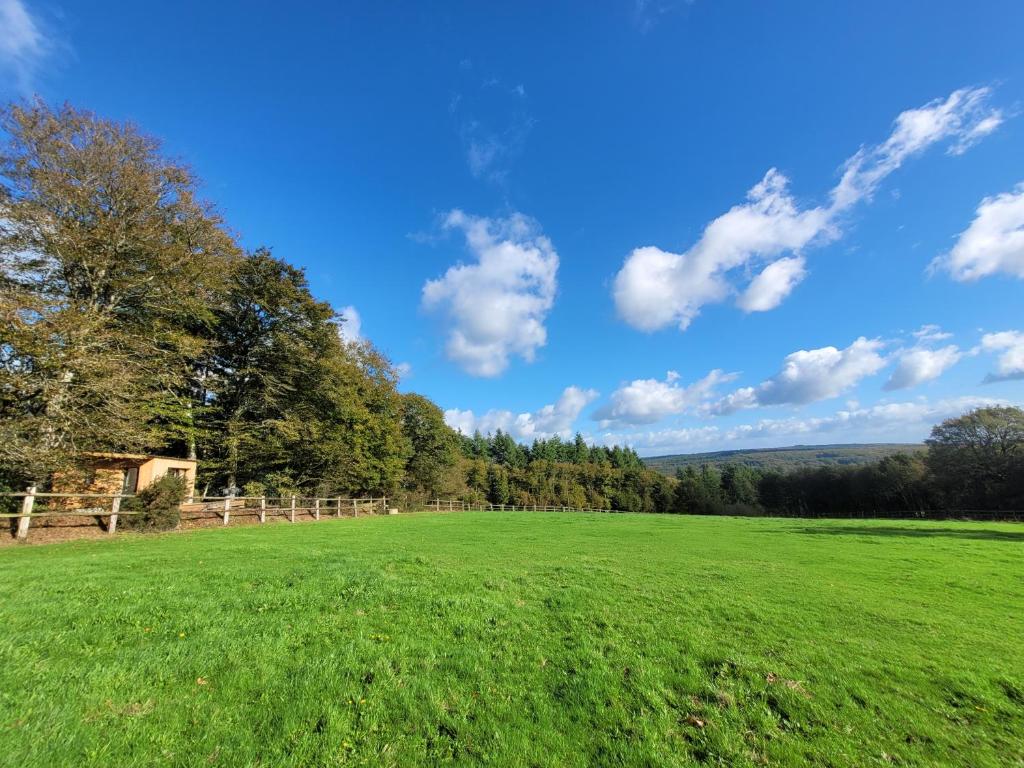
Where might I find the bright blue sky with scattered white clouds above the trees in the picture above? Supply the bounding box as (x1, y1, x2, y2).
(0, 0, 1024, 455)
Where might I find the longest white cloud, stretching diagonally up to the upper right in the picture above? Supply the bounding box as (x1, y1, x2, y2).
(612, 88, 1001, 331)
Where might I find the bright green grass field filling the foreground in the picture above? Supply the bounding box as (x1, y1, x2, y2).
(0, 513, 1024, 768)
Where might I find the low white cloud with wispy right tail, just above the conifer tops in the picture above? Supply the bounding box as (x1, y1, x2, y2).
(594, 370, 735, 429)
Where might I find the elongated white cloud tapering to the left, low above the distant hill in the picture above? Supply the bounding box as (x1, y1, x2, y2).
(708, 336, 886, 415)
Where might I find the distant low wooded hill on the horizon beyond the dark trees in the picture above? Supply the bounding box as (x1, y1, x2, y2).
(643, 442, 924, 475)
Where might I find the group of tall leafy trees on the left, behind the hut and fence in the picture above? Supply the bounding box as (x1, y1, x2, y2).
(0, 101, 454, 496)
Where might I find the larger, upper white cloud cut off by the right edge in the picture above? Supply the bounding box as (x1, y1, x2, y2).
(932, 183, 1024, 282)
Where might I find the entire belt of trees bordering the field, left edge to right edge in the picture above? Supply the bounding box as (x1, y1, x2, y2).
(0, 101, 1024, 515)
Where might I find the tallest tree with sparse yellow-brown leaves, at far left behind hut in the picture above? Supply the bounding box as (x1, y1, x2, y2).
(0, 101, 237, 478)
